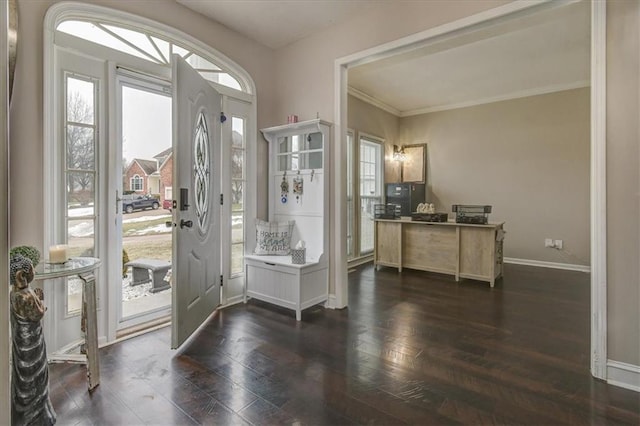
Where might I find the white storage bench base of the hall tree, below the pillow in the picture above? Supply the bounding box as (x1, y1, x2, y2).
(244, 255, 329, 321)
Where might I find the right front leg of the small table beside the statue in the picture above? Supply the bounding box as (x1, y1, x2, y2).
(79, 272, 100, 391)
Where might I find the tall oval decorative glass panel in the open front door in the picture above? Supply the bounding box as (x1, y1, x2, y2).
(193, 112, 210, 232)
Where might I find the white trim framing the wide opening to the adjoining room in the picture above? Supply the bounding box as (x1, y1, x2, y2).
(333, 2, 607, 379)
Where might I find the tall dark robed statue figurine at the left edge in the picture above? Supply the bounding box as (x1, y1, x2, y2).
(10, 255, 56, 426)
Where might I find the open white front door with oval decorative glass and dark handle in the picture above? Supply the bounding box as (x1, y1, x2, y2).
(171, 55, 221, 348)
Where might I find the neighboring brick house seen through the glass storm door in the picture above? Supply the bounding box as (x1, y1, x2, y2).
(122, 148, 173, 201)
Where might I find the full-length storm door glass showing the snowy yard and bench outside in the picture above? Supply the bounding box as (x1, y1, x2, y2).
(114, 74, 173, 330)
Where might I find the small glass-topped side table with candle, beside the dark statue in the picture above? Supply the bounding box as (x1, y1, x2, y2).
(34, 257, 102, 391)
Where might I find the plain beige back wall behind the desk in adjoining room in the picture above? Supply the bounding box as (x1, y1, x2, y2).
(399, 88, 590, 265)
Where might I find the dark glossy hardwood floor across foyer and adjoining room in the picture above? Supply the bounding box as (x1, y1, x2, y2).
(50, 265, 640, 425)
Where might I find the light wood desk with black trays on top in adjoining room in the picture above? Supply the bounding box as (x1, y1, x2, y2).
(374, 219, 504, 287)
